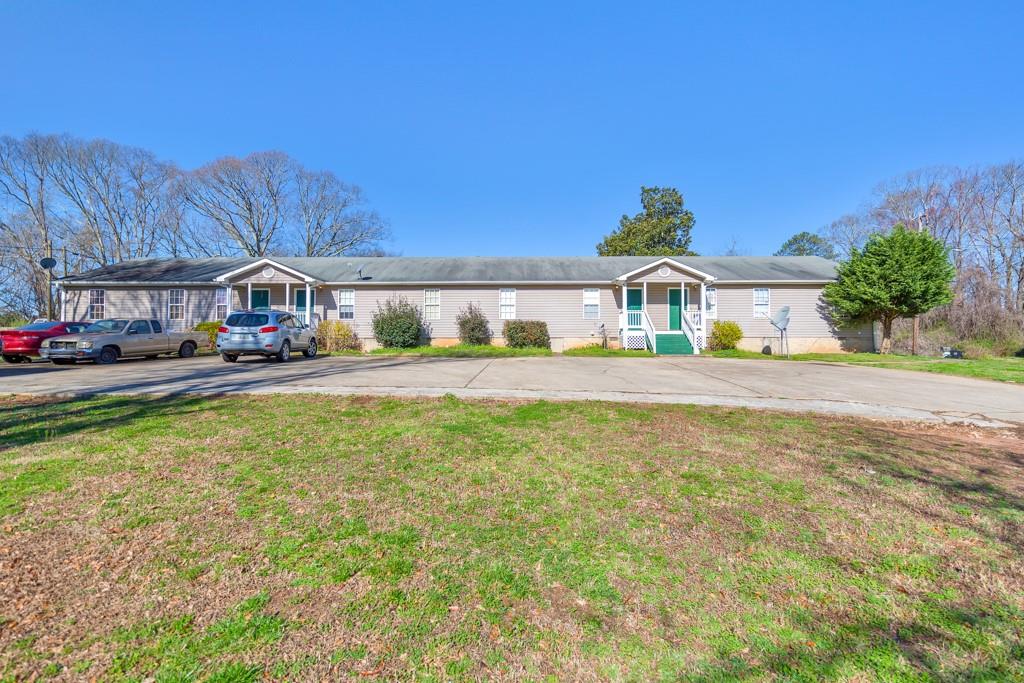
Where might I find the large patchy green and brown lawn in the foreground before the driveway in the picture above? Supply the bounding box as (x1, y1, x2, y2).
(0, 395, 1024, 681)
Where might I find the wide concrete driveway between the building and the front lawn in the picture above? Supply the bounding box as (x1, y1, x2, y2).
(0, 356, 1024, 426)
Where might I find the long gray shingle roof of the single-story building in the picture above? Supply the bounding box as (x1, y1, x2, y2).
(63, 256, 836, 285)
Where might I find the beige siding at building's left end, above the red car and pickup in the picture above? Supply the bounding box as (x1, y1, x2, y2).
(63, 287, 217, 330)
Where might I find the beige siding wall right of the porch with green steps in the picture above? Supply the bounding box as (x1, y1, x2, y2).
(717, 283, 870, 339)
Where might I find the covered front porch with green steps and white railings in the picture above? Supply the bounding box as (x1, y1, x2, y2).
(615, 258, 714, 355)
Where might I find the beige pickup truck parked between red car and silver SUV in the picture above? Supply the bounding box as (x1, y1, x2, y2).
(39, 317, 203, 365)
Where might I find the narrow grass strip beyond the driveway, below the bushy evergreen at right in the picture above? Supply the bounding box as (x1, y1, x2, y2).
(707, 349, 1024, 383)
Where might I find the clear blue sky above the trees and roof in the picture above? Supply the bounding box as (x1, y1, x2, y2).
(0, 0, 1024, 256)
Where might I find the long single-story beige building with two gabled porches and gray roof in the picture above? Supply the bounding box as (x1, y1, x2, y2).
(59, 256, 872, 353)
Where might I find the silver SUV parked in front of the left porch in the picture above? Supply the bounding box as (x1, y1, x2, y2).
(217, 310, 316, 362)
